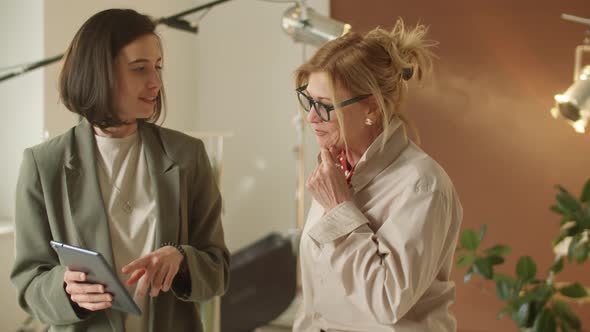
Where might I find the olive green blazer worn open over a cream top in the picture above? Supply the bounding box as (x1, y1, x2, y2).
(11, 120, 229, 332)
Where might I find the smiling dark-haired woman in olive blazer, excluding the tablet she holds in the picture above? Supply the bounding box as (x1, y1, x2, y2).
(11, 9, 229, 331)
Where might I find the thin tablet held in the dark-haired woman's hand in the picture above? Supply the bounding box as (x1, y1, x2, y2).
(50, 241, 141, 315)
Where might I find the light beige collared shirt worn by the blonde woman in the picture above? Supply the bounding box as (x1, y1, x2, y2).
(293, 119, 463, 332)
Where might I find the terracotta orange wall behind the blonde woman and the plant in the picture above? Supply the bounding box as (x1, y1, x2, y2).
(331, 0, 590, 332)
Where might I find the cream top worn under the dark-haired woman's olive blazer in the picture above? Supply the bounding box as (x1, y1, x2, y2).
(95, 132, 156, 332)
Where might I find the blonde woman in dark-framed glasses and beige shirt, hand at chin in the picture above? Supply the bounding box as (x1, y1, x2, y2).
(294, 20, 463, 332)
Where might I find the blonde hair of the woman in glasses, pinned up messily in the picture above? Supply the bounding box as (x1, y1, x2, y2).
(295, 19, 437, 145)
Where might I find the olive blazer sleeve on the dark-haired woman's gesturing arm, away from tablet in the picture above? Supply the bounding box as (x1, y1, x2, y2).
(172, 141, 230, 302)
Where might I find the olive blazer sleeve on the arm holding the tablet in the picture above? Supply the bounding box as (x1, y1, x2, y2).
(10, 149, 89, 325)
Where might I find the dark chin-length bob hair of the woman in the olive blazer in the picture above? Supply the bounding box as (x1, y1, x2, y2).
(59, 9, 165, 128)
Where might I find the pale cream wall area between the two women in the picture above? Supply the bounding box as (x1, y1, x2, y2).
(193, 0, 329, 249)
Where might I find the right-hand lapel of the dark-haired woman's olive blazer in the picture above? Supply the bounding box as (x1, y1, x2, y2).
(139, 122, 180, 248)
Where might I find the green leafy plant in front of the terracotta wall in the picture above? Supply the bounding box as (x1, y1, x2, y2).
(456, 180, 590, 332)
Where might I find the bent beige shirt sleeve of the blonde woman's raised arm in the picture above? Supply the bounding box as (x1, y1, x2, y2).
(308, 182, 460, 324)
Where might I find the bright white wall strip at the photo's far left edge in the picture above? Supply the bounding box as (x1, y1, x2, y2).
(0, 0, 44, 331)
